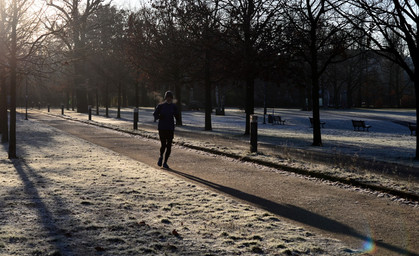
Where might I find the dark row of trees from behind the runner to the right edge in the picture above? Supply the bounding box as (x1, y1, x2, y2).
(124, 0, 417, 150)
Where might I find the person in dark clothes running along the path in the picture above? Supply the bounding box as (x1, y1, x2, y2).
(153, 91, 179, 168)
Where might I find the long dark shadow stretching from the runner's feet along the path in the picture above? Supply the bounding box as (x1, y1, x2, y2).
(168, 169, 418, 256)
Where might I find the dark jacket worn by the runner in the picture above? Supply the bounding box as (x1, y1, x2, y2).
(153, 102, 179, 131)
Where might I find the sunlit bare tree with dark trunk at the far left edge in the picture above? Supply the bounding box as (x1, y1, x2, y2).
(0, 0, 52, 158)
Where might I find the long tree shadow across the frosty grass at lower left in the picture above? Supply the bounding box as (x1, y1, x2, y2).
(12, 159, 75, 255)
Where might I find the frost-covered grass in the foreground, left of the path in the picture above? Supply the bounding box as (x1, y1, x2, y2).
(0, 117, 353, 255)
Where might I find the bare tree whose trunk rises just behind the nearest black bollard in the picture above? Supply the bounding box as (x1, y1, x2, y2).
(221, 0, 283, 134)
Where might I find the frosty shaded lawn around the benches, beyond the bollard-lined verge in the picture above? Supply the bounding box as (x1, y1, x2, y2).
(53, 108, 419, 167)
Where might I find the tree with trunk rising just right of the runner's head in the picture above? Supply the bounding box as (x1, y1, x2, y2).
(128, 0, 193, 125)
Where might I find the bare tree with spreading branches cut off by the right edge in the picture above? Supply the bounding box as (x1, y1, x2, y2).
(335, 0, 419, 160)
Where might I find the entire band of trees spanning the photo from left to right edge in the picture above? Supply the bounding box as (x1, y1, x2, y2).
(0, 0, 419, 158)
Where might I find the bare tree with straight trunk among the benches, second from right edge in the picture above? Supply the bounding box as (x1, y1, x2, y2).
(285, 0, 349, 146)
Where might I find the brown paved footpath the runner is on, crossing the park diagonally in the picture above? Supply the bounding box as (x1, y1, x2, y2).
(32, 113, 419, 255)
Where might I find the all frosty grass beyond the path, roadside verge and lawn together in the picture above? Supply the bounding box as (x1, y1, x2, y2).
(37, 108, 419, 195)
